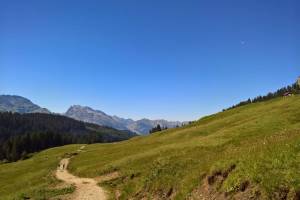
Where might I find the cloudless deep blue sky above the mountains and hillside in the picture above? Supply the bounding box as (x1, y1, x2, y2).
(0, 0, 300, 120)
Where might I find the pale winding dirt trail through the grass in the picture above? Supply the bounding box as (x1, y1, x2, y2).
(56, 147, 107, 200)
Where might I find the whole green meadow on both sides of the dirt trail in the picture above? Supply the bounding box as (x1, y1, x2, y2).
(0, 96, 300, 200)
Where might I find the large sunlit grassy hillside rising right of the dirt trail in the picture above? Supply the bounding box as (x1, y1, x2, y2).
(70, 96, 300, 199)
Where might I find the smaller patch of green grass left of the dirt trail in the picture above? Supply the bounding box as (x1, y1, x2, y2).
(0, 145, 81, 200)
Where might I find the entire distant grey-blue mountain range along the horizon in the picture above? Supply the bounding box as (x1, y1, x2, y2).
(0, 95, 182, 135)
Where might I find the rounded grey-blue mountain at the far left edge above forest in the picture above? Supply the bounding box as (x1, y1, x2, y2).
(0, 95, 50, 113)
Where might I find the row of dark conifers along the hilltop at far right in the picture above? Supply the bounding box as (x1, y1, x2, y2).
(223, 83, 300, 111)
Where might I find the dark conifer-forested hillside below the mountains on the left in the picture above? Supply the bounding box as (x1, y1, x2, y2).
(0, 112, 135, 161)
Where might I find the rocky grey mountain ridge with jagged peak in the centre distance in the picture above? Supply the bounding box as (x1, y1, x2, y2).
(65, 105, 182, 134)
